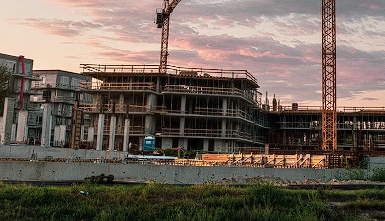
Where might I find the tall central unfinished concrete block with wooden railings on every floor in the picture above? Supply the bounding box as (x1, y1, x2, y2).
(79, 64, 270, 152)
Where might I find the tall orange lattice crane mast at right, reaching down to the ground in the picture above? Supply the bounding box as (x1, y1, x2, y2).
(322, 0, 337, 151)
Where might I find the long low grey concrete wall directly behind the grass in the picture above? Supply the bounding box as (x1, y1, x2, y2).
(0, 161, 356, 184)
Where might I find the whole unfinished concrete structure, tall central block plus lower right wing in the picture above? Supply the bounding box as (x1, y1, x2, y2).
(74, 64, 385, 157)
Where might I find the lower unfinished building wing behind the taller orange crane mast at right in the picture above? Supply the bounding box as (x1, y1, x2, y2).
(269, 105, 385, 154)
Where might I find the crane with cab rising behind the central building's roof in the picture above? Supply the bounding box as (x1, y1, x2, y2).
(155, 0, 181, 73)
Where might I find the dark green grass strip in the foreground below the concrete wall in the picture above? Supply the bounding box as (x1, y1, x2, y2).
(0, 183, 385, 221)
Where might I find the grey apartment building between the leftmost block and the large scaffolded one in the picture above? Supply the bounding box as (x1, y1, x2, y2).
(28, 70, 92, 147)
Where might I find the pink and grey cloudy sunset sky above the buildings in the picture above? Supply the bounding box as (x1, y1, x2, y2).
(0, 0, 385, 108)
